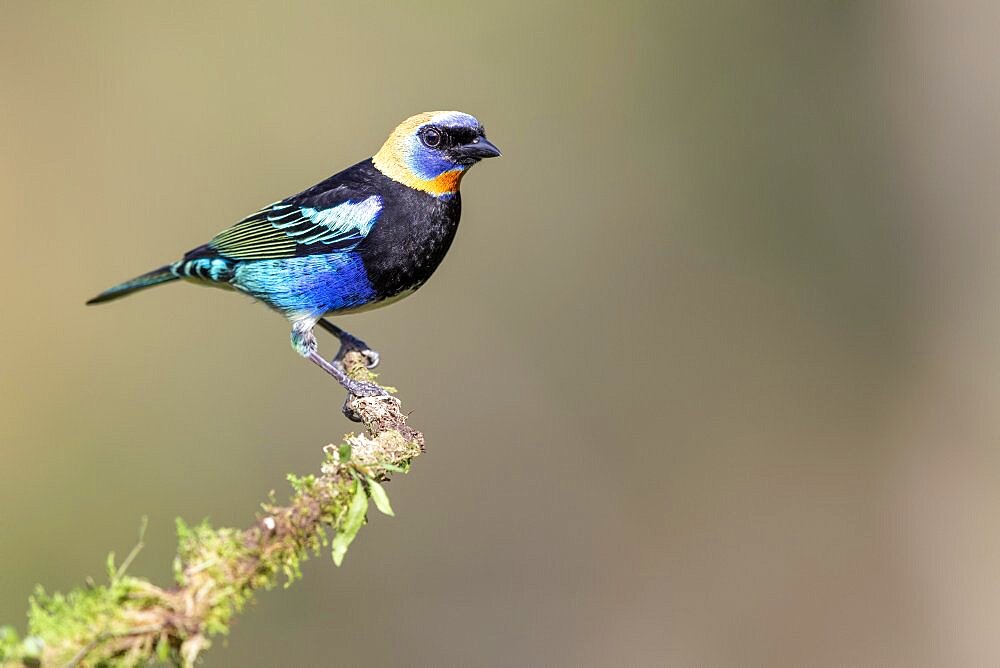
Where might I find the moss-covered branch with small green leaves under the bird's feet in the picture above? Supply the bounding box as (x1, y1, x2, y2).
(0, 352, 424, 667)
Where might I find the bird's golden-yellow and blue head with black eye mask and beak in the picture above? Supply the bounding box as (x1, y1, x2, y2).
(372, 111, 500, 198)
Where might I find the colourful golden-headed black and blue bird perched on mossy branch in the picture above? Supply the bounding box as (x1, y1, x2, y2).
(87, 111, 501, 402)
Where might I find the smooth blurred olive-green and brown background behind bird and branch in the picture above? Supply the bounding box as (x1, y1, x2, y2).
(0, 0, 1000, 666)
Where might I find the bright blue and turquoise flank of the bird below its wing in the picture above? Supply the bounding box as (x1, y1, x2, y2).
(232, 252, 376, 315)
